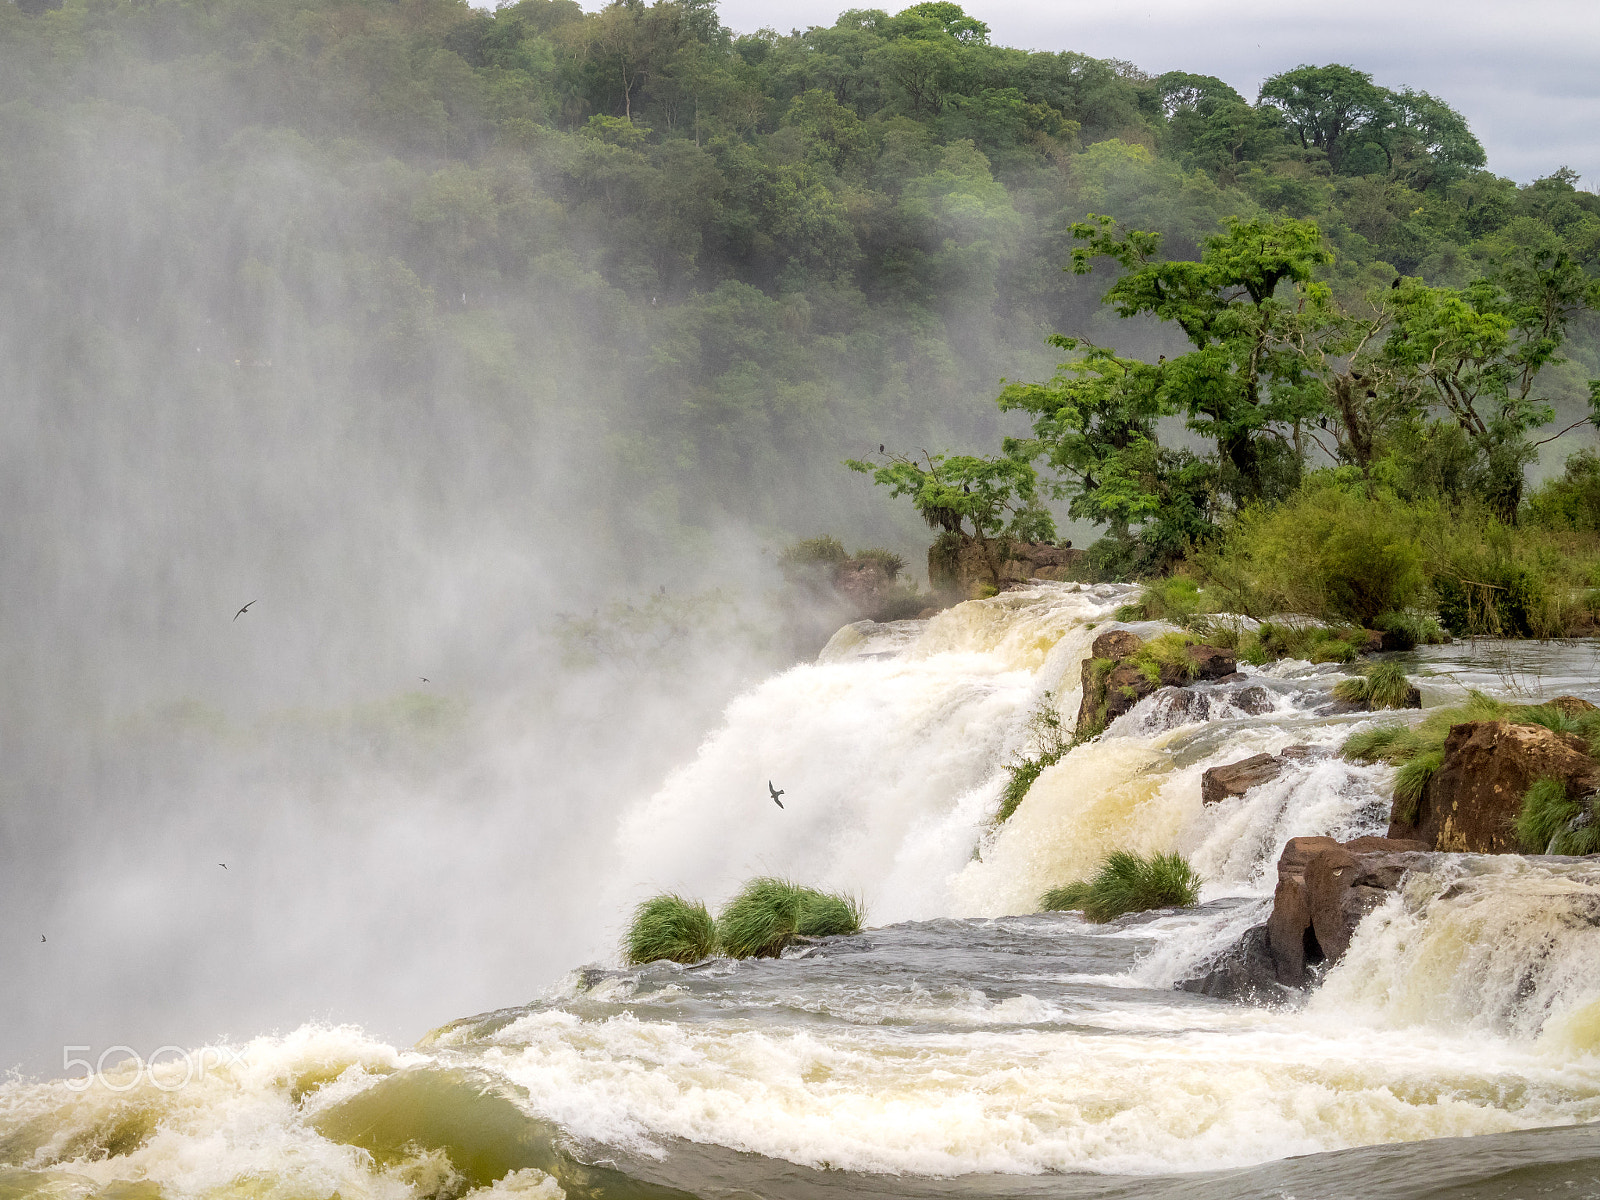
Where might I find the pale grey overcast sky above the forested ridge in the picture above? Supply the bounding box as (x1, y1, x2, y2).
(534, 0, 1600, 190)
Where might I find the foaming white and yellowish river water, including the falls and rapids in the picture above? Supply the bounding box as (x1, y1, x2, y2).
(0, 586, 1600, 1200)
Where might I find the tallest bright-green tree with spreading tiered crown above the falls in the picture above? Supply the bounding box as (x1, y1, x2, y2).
(1072, 214, 1333, 504)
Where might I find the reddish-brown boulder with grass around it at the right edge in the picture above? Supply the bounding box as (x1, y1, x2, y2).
(1389, 722, 1600, 854)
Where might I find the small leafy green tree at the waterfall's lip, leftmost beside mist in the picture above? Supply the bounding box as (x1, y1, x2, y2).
(845, 451, 1056, 586)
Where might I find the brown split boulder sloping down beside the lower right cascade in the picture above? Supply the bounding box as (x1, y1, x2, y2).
(1178, 837, 1430, 1002)
